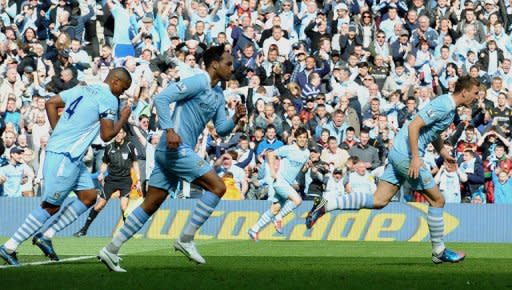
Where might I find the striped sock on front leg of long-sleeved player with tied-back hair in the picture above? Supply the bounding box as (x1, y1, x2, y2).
(180, 191, 220, 243)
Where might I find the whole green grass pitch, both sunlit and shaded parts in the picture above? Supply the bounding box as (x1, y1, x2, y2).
(0, 238, 512, 290)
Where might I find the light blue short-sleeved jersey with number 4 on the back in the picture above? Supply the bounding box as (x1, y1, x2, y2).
(46, 84, 119, 158)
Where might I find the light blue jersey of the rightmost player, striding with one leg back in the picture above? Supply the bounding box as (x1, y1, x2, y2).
(392, 95, 456, 157)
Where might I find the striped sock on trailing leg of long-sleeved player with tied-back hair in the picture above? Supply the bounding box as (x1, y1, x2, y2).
(107, 206, 149, 254)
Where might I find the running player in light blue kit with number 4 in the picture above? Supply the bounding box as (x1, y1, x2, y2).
(0, 68, 131, 265)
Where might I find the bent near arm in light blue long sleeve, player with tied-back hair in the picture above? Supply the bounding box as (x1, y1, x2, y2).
(155, 73, 210, 130)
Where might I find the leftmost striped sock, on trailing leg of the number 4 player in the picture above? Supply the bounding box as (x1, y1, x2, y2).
(4, 207, 50, 253)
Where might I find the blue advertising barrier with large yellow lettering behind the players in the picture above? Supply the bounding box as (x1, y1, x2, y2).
(0, 198, 512, 243)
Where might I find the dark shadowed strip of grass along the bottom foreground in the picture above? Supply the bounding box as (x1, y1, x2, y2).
(0, 256, 512, 290)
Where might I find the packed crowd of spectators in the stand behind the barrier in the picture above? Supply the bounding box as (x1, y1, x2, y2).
(0, 0, 512, 204)
